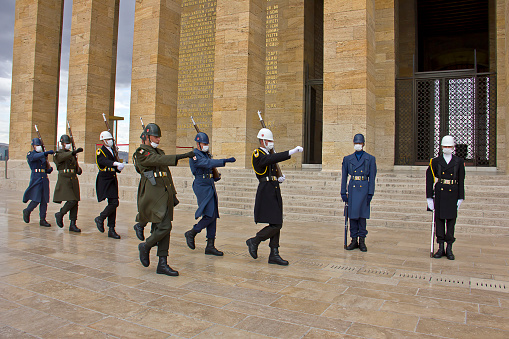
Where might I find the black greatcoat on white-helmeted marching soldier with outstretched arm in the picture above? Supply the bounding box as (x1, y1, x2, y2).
(251, 148, 291, 224)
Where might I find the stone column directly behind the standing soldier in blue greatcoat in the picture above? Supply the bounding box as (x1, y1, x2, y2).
(322, 0, 375, 170)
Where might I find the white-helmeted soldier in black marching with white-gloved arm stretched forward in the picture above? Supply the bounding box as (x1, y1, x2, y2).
(246, 128, 304, 265)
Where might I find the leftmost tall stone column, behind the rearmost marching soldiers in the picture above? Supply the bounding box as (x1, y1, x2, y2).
(9, 0, 64, 159)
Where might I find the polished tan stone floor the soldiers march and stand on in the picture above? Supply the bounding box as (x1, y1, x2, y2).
(0, 190, 509, 339)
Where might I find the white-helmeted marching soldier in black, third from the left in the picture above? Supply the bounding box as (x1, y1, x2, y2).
(94, 131, 124, 239)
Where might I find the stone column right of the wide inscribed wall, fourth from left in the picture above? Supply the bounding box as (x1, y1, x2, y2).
(212, 0, 266, 168)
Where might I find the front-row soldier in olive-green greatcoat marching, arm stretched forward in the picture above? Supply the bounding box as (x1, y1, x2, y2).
(133, 124, 194, 276)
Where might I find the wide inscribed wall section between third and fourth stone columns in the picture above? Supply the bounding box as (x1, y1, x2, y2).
(177, 0, 216, 146)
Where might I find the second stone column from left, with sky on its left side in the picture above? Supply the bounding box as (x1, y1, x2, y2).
(67, 0, 119, 163)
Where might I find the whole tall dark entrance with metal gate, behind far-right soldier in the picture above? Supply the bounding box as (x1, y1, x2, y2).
(395, 0, 496, 166)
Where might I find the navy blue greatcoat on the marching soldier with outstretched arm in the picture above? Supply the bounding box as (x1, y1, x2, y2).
(189, 148, 224, 219)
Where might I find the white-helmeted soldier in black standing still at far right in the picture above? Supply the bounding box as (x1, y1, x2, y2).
(426, 135, 465, 260)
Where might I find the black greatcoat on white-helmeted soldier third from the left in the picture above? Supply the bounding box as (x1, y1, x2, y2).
(95, 145, 120, 201)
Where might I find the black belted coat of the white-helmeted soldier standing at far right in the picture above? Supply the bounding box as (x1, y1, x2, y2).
(426, 155, 465, 219)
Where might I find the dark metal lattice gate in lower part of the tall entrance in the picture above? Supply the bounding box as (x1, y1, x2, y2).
(395, 70, 496, 166)
